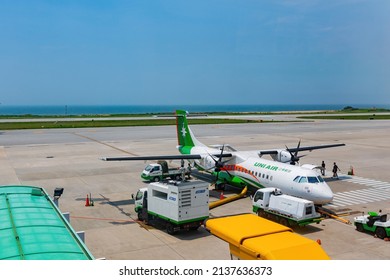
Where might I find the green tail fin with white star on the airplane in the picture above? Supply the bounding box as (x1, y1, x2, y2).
(176, 110, 204, 153)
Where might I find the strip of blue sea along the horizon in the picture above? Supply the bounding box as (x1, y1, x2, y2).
(0, 103, 390, 116)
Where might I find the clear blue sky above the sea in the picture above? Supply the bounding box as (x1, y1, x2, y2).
(0, 0, 390, 105)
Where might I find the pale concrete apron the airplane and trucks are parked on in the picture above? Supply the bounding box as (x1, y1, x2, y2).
(0, 116, 390, 260)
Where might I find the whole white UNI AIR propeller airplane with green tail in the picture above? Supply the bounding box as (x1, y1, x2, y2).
(103, 110, 345, 205)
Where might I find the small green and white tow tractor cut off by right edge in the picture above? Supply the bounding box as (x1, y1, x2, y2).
(354, 211, 390, 239)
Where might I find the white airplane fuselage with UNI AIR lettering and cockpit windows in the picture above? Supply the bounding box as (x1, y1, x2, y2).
(183, 146, 333, 204)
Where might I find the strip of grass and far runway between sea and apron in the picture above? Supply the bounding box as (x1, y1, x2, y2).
(0, 109, 390, 130)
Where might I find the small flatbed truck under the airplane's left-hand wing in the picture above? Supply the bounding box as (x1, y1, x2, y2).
(141, 160, 191, 182)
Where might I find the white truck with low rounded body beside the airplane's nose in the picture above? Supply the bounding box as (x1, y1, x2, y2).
(252, 188, 322, 227)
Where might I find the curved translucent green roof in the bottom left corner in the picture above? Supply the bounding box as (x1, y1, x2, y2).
(0, 186, 93, 260)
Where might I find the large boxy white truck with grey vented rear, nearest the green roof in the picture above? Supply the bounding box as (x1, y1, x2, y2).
(132, 180, 209, 234)
